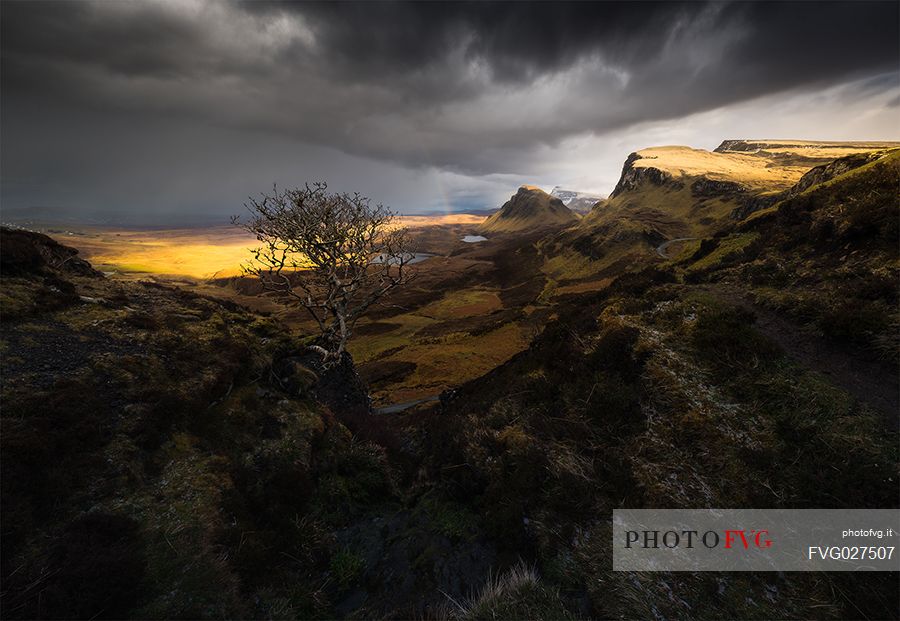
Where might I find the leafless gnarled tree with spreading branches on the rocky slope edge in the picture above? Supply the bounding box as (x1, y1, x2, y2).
(232, 183, 415, 367)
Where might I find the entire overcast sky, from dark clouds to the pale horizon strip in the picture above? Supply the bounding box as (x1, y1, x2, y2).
(0, 0, 900, 221)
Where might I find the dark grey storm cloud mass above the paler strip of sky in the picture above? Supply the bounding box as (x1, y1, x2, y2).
(0, 0, 900, 217)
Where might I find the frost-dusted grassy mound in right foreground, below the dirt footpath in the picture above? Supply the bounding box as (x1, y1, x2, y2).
(425, 271, 900, 619)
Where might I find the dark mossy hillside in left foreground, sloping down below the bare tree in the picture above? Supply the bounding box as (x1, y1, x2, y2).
(0, 229, 510, 618)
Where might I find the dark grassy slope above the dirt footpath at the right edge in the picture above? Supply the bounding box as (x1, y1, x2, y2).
(675, 150, 900, 363)
